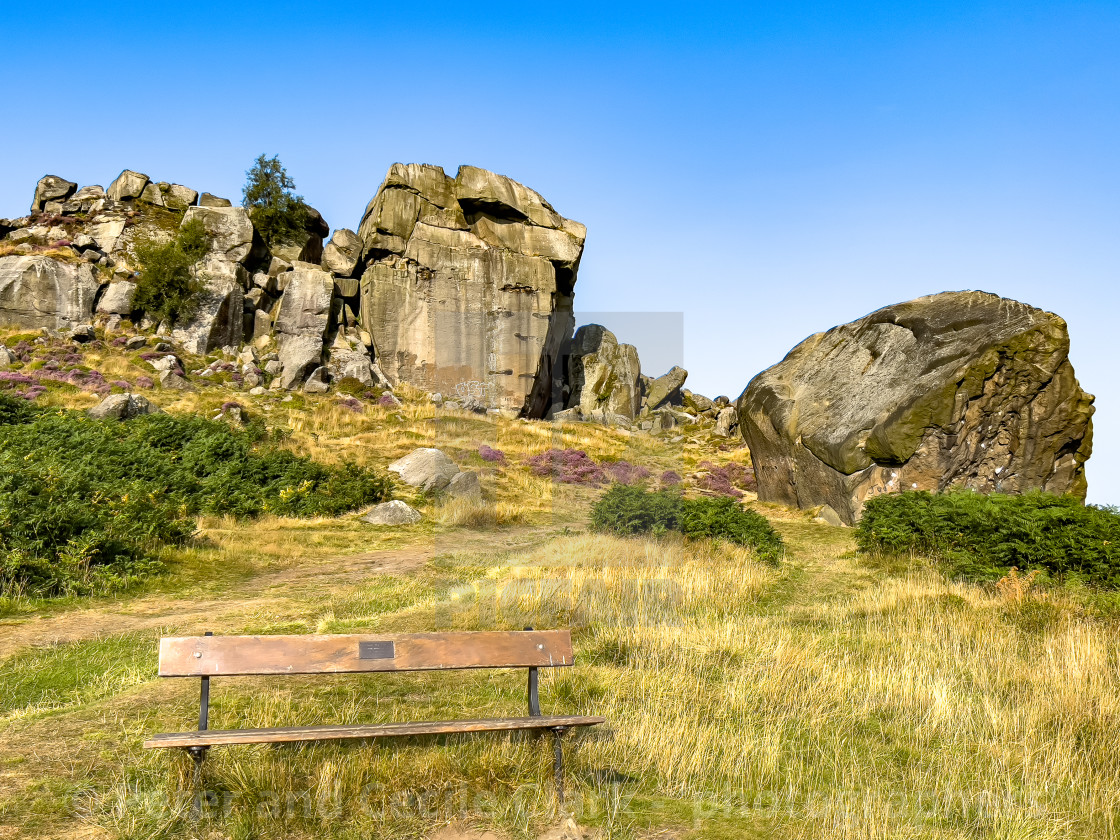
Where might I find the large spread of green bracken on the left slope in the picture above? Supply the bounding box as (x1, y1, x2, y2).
(0, 394, 390, 595)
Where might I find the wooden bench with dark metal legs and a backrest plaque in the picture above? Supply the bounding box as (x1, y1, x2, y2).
(144, 628, 605, 801)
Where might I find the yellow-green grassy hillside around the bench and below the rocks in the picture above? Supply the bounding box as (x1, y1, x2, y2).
(0, 331, 1120, 840)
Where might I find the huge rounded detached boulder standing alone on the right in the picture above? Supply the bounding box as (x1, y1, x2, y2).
(738, 291, 1093, 524)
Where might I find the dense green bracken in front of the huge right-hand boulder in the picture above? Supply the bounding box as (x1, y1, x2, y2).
(856, 491, 1120, 587)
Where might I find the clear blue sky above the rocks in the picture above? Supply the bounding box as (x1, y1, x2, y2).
(0, 0, 1120, 504)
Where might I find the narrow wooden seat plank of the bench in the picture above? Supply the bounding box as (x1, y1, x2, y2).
(144, 715, 606, 749)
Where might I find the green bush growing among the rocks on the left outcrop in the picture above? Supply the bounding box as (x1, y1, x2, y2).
(132, 218, 209, 324)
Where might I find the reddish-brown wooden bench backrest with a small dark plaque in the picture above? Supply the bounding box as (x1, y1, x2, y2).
(159, 629, 572, 676)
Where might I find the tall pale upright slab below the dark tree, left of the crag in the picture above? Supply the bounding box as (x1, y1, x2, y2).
(274, 263, 334, 390)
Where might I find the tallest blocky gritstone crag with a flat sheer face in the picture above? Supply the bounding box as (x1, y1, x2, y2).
(358, 164, 586, 417)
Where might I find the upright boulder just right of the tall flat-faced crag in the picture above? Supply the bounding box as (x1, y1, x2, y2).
(567, 324, 642, 420)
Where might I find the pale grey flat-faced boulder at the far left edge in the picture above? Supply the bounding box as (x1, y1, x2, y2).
(0, 255, 99, 332)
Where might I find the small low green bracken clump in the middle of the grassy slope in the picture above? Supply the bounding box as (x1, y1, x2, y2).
(591, 484, 783, 562)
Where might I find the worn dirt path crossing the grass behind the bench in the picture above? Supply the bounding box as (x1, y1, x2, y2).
(0, 528, 554, 661)
